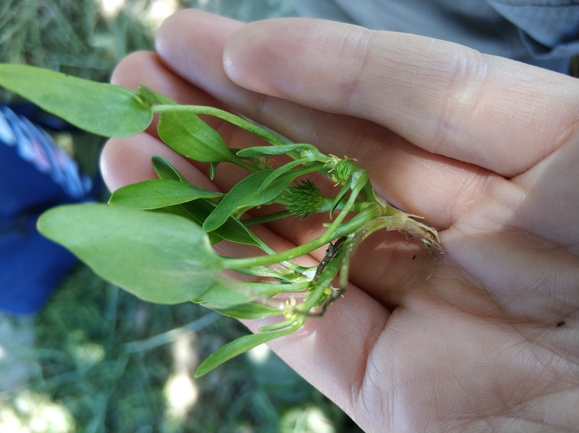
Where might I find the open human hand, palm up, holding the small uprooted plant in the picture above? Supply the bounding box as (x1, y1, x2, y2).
(102, 10, 579, 432)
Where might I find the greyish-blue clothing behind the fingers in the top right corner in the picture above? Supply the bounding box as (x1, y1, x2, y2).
(294, 0, 579, 74)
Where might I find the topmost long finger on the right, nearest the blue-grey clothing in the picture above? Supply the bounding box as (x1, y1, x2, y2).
(224, 19, 579, 177)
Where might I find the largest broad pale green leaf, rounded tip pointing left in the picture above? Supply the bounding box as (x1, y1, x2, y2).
(38, 204, 223, 304)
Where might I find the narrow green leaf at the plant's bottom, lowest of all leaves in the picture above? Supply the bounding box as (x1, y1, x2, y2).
(195, 324, 301, 377)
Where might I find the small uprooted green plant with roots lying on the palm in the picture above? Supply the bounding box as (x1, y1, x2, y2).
(0, 64, 442, 376)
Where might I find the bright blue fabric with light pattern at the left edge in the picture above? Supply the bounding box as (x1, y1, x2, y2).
(0, 106, 94, 314)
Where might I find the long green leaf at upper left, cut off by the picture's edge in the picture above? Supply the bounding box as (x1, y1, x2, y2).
(0, 64, 153, 137)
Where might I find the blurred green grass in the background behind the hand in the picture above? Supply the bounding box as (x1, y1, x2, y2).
(0, 0, 358, 433)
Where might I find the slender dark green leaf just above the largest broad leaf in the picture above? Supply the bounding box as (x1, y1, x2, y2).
(109, 179, 223, 210)
